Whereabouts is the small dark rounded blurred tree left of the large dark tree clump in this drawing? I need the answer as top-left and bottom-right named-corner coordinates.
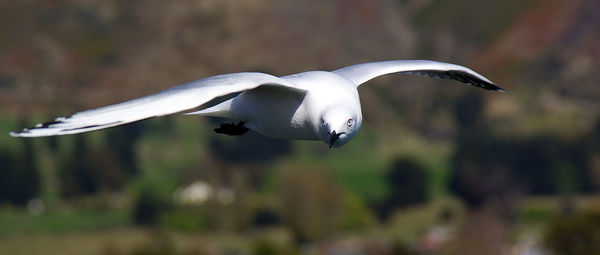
top-left (375, 157), bottom-right (427, 220)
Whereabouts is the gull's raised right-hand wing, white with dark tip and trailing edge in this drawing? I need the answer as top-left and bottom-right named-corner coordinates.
top-left (333, 60), bottom-right (510, 93)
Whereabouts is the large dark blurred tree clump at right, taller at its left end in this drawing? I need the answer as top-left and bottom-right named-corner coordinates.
top-left (450, 93), bottom-right (594, 206)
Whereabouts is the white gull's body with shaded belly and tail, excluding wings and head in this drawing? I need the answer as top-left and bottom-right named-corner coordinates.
top-left (195, 71), bottom-right (362, 140)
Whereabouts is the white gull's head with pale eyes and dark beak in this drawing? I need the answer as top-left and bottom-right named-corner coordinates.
top-left (319, 107), bottom-right (362, 148)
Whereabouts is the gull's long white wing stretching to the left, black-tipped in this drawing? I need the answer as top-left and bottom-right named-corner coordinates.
top-left (10, 73), bottom-right (299, 137)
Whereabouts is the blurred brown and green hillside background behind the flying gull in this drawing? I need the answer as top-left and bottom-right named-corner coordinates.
top-left (0, 0), bottom-right (600, 255)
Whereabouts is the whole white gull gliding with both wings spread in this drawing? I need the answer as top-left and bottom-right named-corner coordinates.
top-left (10, 60), bottom-right (510, 148)
